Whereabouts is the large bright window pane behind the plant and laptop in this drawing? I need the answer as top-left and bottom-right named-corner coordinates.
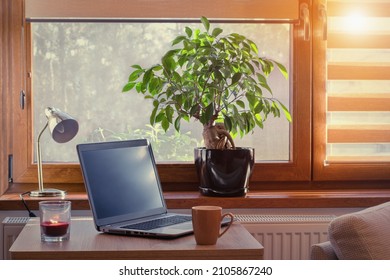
top-left (32, 23), bottom-right (292, 162)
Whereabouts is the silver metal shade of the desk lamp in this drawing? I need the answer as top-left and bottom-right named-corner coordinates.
top-left (45, 107), bottom-right (79, 143)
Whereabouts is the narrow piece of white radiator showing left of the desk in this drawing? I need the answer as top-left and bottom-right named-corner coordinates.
top-left (2, 217), bottom-right (29, 260)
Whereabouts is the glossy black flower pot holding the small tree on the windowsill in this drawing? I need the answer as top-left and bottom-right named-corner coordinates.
top-left (194, 148), bottom-right (255, 197)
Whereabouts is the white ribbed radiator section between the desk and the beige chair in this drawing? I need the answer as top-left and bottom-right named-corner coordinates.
top-left (235, 215), bottom-right (335, 260)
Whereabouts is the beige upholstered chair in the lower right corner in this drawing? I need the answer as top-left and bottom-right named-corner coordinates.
top-left (310, 202), bottom-right (390, 260)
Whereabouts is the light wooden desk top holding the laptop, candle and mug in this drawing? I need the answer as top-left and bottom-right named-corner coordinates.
top-left (10, 217), bottom-right (263, 260)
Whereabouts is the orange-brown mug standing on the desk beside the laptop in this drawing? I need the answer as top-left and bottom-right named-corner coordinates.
top-left (192, 206), bottom-right (234, 245)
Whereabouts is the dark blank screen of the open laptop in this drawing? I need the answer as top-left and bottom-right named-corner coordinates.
top-left (77, 140), bottom-right (165, 226)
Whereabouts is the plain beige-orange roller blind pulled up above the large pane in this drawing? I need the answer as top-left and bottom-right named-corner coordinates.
top-left (25, 0), bottom-right (299, 21)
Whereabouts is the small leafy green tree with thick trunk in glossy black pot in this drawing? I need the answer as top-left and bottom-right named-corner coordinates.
top-left (123, 17), bottom-right (291, 196)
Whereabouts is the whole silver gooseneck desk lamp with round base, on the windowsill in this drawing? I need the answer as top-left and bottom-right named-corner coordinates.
top-left (30, 107), bottom-right (79, 197)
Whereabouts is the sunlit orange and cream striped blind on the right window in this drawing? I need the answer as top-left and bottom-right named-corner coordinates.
top-left (326, 0), bottom-right (390, 164)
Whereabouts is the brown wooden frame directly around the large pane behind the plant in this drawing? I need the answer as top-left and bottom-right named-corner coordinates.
top-left (7, 1), bottom-right (311, 190)
